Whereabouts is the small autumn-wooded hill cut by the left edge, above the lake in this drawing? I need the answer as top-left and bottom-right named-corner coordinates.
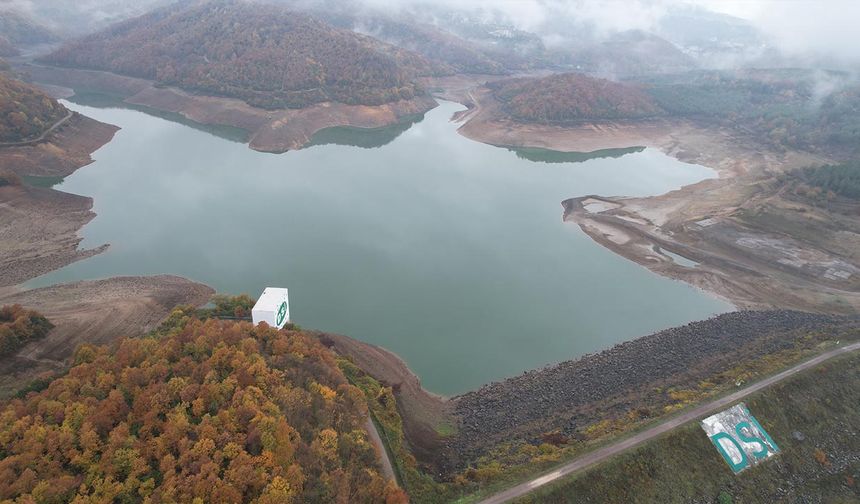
top-left (0, 71), bottom-right (68, 142)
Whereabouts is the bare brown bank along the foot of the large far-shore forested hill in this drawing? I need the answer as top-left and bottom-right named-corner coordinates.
top-left (21, 65), bottom-right (437, 153)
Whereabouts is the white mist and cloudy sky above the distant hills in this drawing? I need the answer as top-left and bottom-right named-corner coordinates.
top-left (0, 0), bottom-right (860, 71)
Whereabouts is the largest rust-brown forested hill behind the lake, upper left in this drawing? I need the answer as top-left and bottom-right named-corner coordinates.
top-left (44, 0), bottom-right (440, 108)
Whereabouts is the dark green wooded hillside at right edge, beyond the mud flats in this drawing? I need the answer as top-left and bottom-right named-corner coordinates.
top-left (639, 69), bottom-right (860, 158)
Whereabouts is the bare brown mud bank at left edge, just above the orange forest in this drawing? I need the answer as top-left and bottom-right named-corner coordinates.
top-left (0, 275), bottom-right (213, 397)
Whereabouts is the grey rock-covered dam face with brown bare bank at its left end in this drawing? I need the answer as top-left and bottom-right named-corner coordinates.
top-left (315, 310), bottom-right (860, 479)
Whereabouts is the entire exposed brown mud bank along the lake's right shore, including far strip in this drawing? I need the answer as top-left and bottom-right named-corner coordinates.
top-left (459, 88), bottom-right (860, 314)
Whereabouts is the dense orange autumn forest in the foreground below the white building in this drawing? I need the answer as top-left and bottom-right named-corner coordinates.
top-left (0, 310), bottom-right (407, 504)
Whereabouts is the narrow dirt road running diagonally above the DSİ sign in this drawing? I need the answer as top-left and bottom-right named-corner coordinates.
top-left (481, 343), bottom-right (860, 504)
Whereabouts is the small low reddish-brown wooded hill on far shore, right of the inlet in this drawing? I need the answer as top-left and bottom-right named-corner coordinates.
top-left (487, 73), bottom-right (663, 122)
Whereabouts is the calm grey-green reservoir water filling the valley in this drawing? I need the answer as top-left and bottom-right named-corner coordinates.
top-left (32, 98), bottom-right (731, 394)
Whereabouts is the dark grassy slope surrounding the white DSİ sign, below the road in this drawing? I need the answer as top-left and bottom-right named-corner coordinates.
top-left (522, 353), bottom-right (860, 503)
